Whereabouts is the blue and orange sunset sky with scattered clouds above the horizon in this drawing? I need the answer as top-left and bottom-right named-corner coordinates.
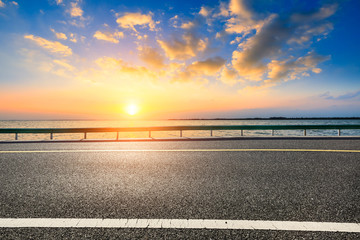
top-left (0, 0), bottom-right (360, 120)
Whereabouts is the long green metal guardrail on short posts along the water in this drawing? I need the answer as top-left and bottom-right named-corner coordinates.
top-left (0, 125), bottom-right (360, 140)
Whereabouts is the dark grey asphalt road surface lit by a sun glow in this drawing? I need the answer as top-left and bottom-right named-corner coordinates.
top-left (0, 139), bottom-right (360, 239)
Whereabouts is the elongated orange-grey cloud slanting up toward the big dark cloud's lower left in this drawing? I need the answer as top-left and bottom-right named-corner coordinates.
top-left (173, 57), bottom-right (226, 82)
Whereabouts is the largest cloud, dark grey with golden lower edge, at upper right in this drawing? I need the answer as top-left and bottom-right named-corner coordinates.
top-left (227, 1), bottom-right (336, 83)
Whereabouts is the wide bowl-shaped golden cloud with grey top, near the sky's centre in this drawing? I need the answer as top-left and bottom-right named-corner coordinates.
top-left (157, 32), bottom-right (208, 60)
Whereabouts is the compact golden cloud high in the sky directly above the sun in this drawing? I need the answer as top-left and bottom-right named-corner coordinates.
top-left (116, 13), bottom-right (155, 32)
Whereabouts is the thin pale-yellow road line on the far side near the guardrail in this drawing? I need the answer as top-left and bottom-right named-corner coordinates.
top-left (0, 148), bottom-right (360, 154)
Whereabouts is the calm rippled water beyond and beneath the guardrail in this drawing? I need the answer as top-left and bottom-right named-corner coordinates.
top-left (0, 119), bottom-right (360, 141)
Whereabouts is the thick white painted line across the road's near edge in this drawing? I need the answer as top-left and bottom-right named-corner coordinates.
top-left (0, 218), bottom-right (360, 232)
